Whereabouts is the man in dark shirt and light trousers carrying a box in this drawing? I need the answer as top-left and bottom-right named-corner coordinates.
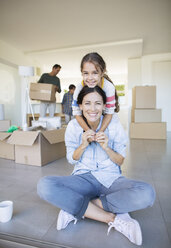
top-left (38, 64), bottom-right (61, 117)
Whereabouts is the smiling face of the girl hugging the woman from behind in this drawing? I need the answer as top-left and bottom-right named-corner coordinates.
top-left (82, 62), bottom-right (103, 88)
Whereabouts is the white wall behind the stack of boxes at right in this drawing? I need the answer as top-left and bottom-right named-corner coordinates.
top-left (128, 53), bottom-right (171, 131)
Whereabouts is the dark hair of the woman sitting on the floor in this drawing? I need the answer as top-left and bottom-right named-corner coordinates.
top-left (77, 85), bottom-right (106, 104)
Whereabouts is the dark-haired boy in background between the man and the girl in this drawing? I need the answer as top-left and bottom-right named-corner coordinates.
top-left (62, 84), bottom-right (75, 124)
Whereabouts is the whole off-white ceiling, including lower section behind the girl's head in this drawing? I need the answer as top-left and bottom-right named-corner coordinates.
top-left (0, 0), bottom-right (171, 76)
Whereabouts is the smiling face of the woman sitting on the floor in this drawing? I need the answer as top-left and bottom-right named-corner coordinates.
top-left (80, 92), bottom-right (105, 125)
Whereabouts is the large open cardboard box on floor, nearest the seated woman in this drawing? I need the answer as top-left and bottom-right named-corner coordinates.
top-left (9, 128), bottom-right (66, 166)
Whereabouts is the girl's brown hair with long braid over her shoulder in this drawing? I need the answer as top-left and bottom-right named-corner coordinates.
top-left (80, 52), bottom-right (120, 113)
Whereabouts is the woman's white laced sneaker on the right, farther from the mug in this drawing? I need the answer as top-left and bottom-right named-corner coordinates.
top-left (108, 213), bottom-right (142, 245)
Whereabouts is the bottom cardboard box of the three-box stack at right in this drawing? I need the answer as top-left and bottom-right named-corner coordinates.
top-left (130, 122), bottom-right (166, 139)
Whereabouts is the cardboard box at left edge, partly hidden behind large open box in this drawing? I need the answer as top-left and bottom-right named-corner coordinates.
top-left (0, 132), bottom-right (15, 160)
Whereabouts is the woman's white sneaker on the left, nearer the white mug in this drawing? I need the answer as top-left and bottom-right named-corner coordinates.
top-left (56, 209), bottom-right (77, 231)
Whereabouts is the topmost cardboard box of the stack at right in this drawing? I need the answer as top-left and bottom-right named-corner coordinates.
top-left (132, 86), bottom-right (156, 109)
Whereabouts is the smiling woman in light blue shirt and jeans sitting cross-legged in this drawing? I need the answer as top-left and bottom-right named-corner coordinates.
top-left (38, 86), bottom-right (155, 245)
